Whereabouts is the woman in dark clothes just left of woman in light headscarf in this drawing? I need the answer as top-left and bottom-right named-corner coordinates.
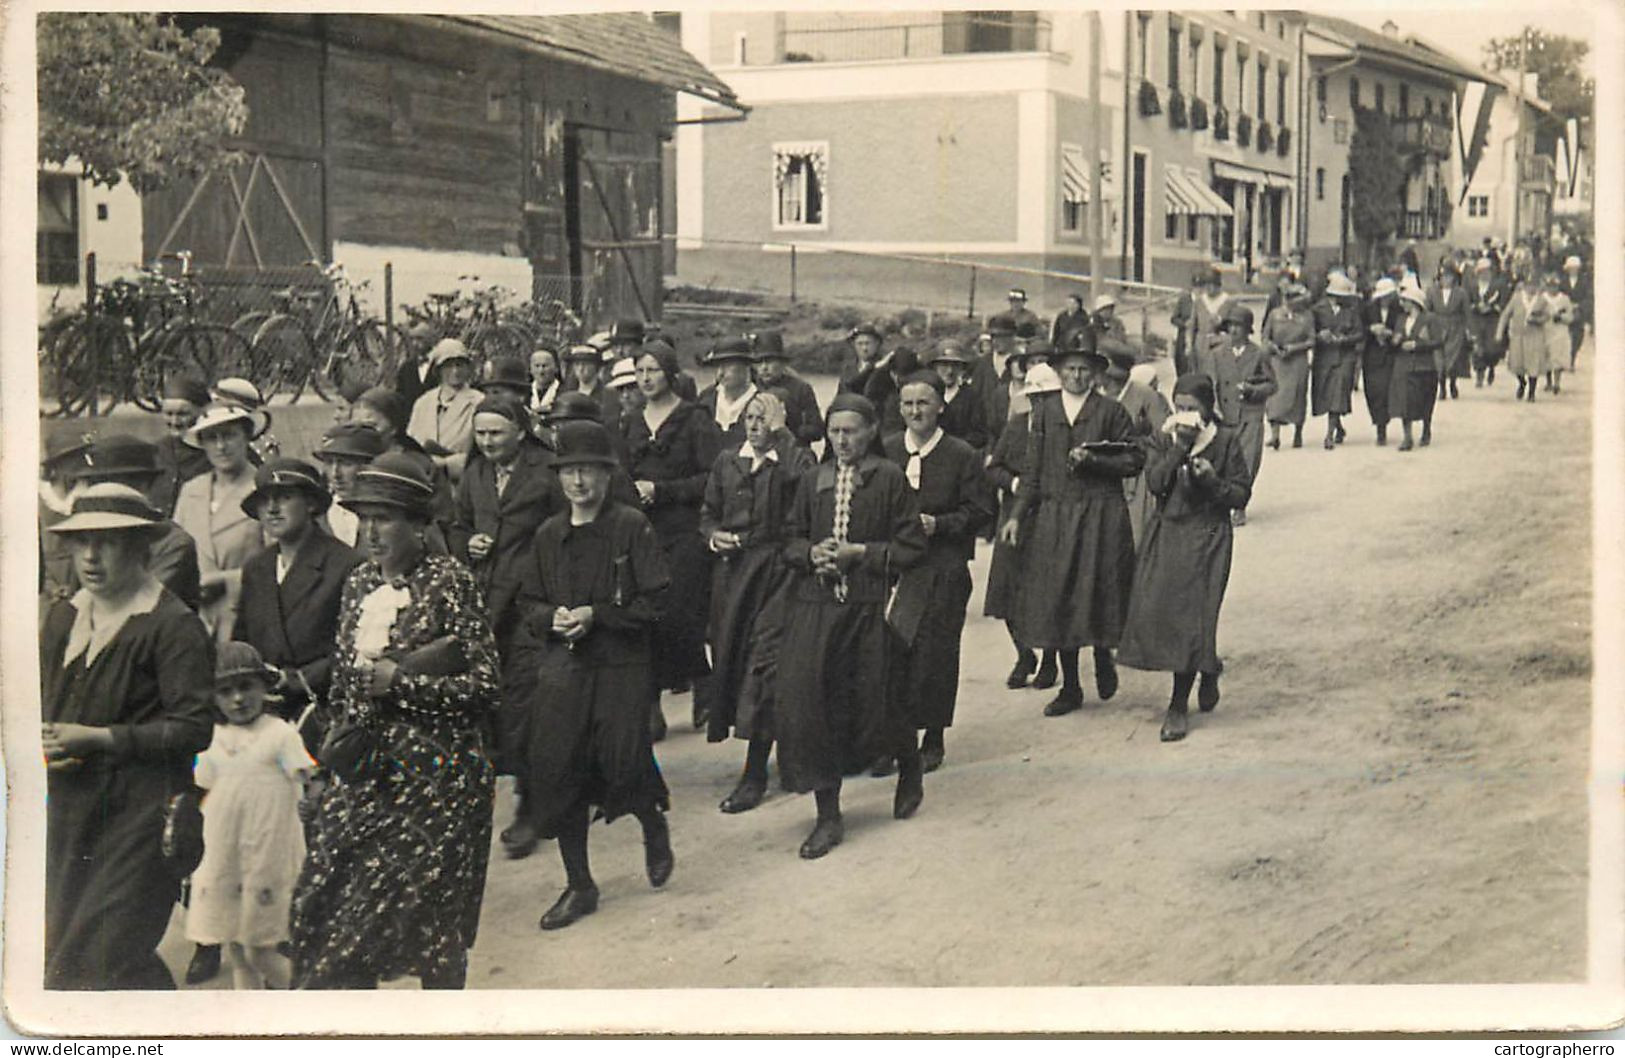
top-left (621, 343), bottom-right (722, 728)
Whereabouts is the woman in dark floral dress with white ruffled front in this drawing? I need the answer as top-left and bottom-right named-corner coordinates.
top-left (293, 453), bottom-right (497, 988)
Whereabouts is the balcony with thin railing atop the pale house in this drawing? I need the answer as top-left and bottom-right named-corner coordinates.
top-left (777, 11), bottom-right (1050, 62)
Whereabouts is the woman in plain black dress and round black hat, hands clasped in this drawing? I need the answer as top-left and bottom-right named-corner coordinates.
top-left (522, 421), bottom-right (676, 930)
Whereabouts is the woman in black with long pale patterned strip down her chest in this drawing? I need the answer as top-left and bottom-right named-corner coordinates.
top-left (774, 393), bottom-right (926, 860)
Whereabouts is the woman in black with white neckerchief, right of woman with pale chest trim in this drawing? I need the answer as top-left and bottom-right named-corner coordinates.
top-left (886, 372), bottom-right (993, 772)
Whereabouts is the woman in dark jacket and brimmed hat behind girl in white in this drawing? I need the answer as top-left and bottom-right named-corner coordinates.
top-left (231, 458), bottom-right (361, 752)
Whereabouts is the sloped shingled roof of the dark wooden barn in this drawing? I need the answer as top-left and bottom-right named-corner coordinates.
top-left (434, 11), bottom-right (746, 111)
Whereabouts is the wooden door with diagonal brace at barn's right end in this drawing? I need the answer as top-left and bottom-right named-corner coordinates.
top-left (566, 128), bottom-right (661, 327)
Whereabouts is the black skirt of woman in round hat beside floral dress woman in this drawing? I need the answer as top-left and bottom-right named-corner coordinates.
top-left (525, 640), bottom-right (671, 837)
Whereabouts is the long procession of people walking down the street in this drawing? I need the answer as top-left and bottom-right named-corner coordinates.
top-left (41, 240), bottom-right (1589, 988)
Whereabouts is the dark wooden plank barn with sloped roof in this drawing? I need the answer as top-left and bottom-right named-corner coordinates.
top-left (141, 13), bottom-right (743, 323)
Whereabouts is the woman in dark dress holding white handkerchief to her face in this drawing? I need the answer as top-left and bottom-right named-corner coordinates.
top-left (1118, 374), bottom-right (1251, 743)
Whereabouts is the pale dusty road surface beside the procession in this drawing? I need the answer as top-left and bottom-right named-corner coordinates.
top-left (143, 349), bottom-right (1591, 988)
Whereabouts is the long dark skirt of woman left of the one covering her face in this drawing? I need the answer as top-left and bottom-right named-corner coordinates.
top-left (1014, 494), bottom-right (1131, 650)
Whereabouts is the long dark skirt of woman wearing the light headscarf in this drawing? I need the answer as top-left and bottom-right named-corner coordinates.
top-left (705, 546), bottom-right (790, 743)
